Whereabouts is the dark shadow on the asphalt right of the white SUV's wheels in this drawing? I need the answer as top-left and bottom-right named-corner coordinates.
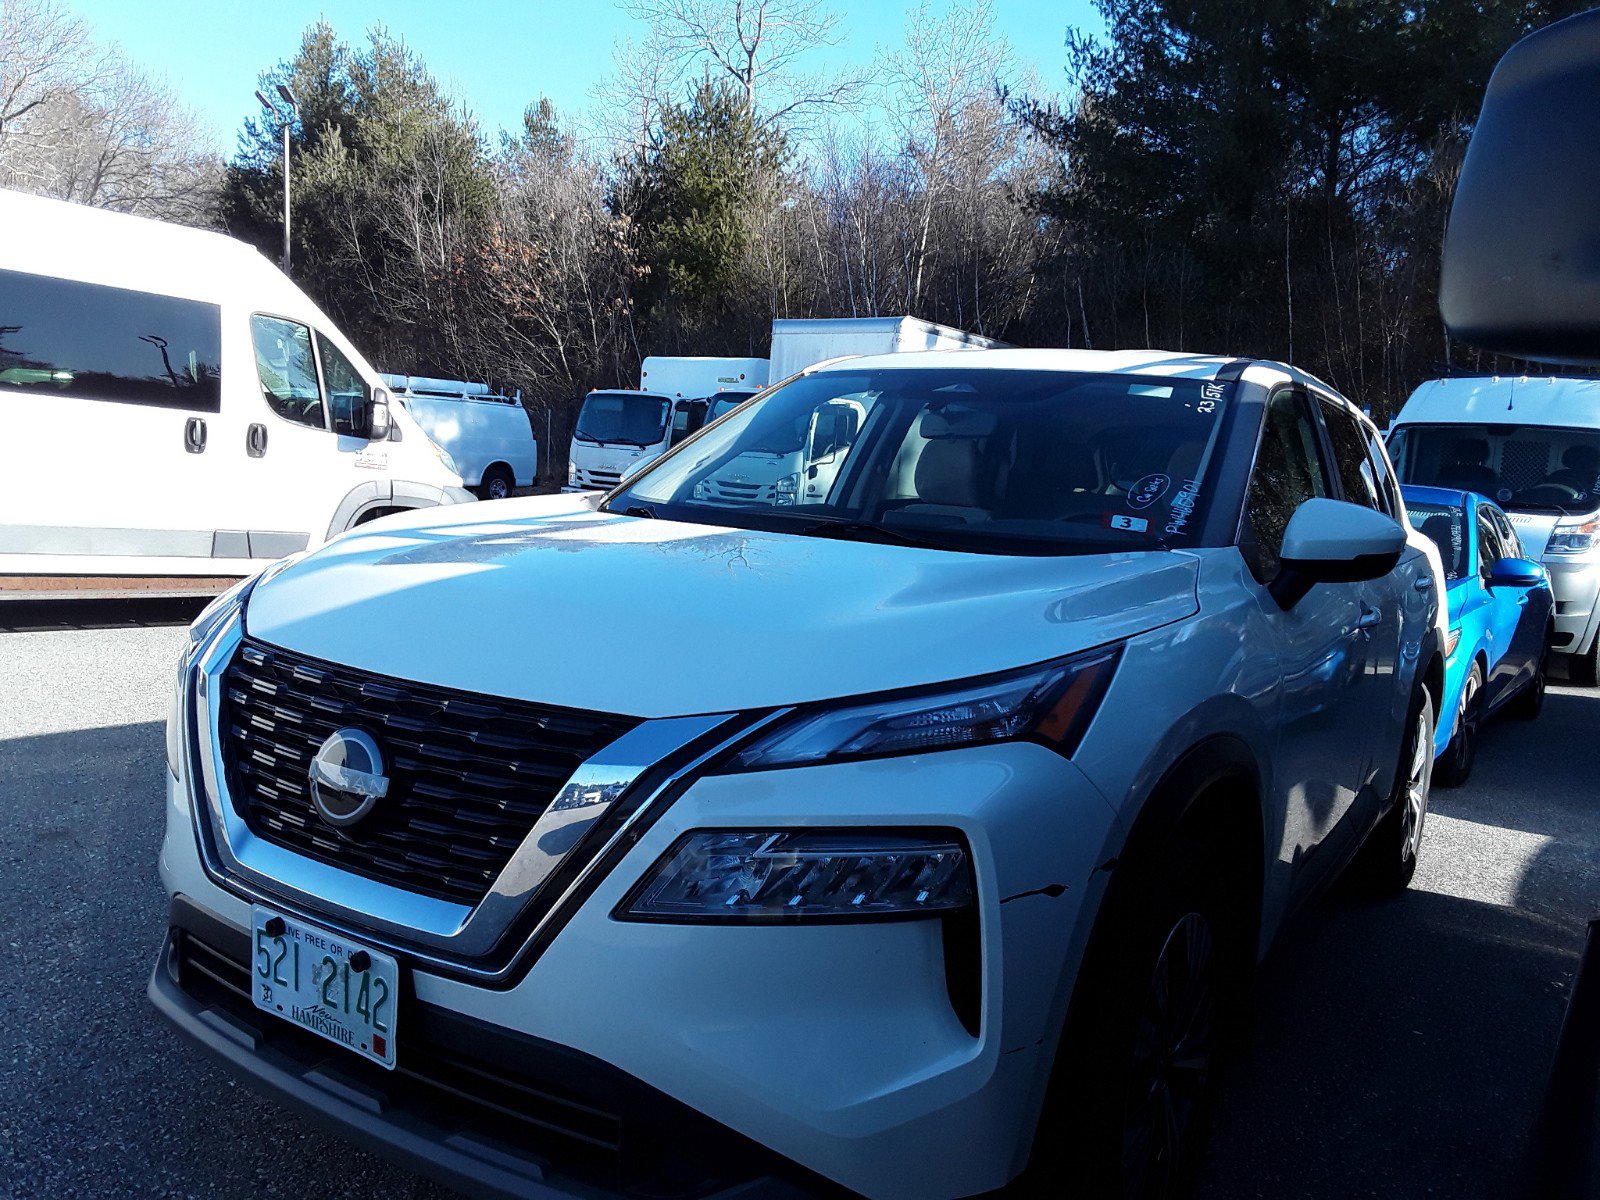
top-left (1197, 891), bottom-right (1582, 1200)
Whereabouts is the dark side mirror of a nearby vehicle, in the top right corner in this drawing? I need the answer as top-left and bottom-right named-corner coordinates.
top-left (1438, 10), bottom-right (1600, 363)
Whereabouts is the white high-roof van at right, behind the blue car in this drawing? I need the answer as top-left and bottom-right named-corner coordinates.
top-left (1389, 376), bottom-right (1600, 685)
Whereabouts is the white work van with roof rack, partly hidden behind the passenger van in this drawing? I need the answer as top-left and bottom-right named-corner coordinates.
top-left (382, 373), bottom-right (539, 499)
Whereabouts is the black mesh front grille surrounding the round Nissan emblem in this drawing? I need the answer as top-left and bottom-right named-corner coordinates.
top-left (219, 640), bottom-right (638, 906)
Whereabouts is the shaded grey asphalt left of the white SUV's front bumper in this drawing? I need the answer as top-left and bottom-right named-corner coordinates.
top-left (0, 722), bottom-right (450, 1200)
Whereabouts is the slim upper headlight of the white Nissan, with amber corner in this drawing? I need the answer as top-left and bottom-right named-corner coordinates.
top-left (725, 645), bottom-right (1122, 771)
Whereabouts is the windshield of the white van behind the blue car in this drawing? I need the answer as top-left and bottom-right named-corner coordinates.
top-left (1389, 424), bottom-right (1600, 512)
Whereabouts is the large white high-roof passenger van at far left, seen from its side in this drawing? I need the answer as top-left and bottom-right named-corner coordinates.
top-left (0, 190), bottom-right (472, 598)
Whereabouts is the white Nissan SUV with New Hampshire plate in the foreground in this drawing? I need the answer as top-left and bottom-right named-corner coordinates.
top-left (150, 350), bottom-right (1443, 1200)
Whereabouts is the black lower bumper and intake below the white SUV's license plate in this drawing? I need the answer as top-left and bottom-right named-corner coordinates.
top-left (149, 896), bottom-right (840, 1200)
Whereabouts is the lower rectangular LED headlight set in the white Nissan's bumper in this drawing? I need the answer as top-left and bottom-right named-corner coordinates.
top-left (616, 829), bottom-right (974, 922)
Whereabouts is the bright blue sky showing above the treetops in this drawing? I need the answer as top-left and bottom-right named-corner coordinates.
top-left (67, 0), bottom-right (1099, 154)
